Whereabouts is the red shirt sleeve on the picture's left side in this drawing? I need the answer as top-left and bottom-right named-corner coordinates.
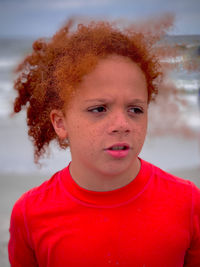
top-left (8, 196), bottom-right (38, 267)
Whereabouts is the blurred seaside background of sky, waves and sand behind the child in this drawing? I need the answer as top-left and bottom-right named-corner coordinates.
top-left (0, 0), bottom-right (200, 267)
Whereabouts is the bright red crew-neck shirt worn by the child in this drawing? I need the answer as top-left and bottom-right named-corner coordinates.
top-left (9, 160), bottom-right (200, 267)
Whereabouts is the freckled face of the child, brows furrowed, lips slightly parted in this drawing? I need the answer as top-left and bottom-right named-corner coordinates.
top-left (52, 56), bottom-right (148, 182)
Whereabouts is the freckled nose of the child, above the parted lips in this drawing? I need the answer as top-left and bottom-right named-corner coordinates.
top-left (108, 112), bottom-right (131, 135)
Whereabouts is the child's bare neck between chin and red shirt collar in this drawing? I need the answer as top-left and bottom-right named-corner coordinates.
top-left (69, 158), bottom-right (141, 192)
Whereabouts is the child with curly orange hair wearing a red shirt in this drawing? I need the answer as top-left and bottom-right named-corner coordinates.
top-left (9, 18), bottom-right (200, 267)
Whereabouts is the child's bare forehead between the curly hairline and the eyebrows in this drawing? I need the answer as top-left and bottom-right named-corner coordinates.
top-left (65, 56), bottom-right (148, 106)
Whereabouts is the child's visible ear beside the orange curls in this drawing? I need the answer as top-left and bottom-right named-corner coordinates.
top-left (50, 109), bottom-right (67, 140)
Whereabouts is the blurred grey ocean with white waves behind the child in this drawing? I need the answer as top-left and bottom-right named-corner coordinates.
top-left (0, 36), bottom-right (200, 173)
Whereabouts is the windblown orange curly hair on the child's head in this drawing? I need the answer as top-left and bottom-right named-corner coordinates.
top-left (14, 17), bottom-right (165, 162)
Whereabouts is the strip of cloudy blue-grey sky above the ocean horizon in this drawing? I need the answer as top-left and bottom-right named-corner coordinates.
top-left (0, 0), bottom-right (200, 38)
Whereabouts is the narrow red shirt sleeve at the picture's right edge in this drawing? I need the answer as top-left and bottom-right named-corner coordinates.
top-left (184, 185), bottom-right (200, 267)
